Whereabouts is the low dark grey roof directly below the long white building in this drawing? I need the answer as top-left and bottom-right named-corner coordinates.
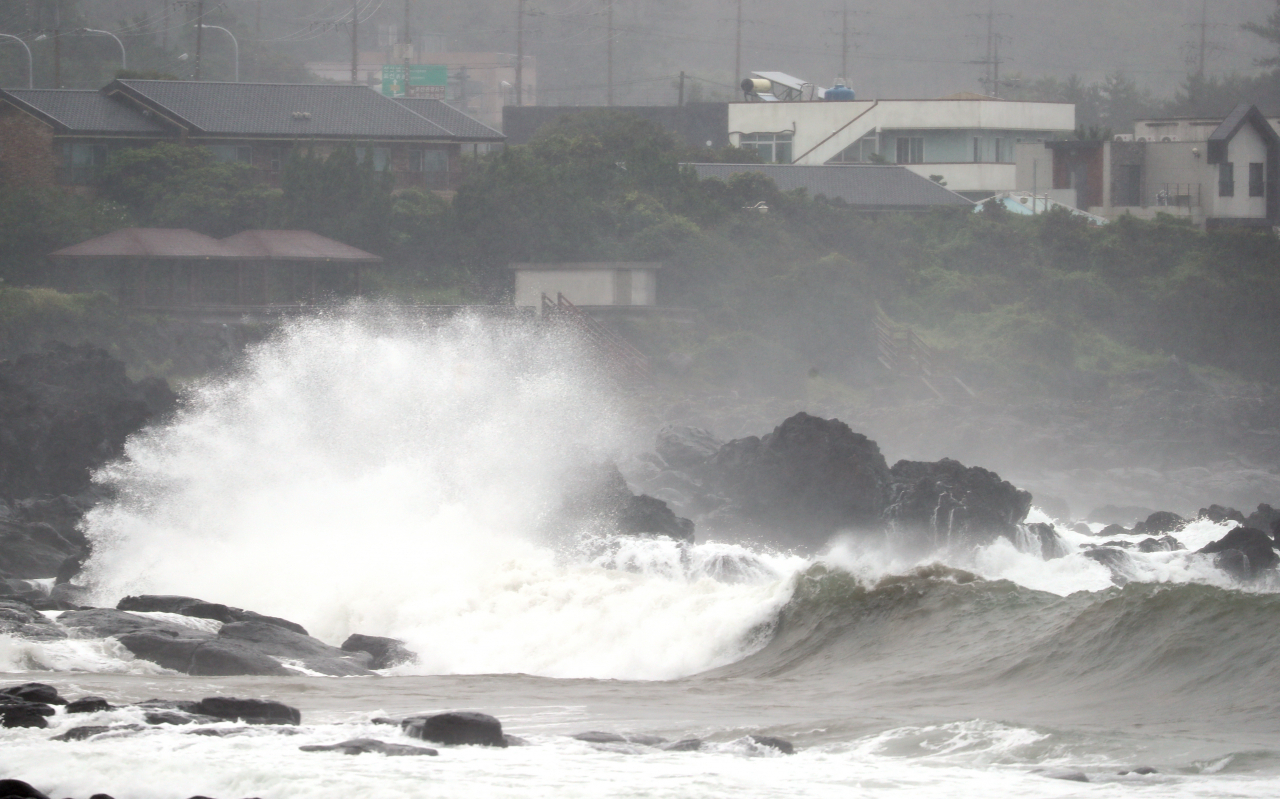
top-left (690, 164), bottom-right (973, 209)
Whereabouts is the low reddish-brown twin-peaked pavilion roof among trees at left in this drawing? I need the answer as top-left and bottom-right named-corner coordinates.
top-left (49, 228), bottom-right (383, 264)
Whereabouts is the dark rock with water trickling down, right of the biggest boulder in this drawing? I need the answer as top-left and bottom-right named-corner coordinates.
top-left (884, 458), bottom-right (1032, 545)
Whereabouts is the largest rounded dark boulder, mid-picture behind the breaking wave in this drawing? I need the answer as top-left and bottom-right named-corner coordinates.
top-left (703, 414), bottom-right (890, 547)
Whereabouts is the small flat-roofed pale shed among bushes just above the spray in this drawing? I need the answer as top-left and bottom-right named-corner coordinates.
top-left (511, 261), bottom-right (662, 309)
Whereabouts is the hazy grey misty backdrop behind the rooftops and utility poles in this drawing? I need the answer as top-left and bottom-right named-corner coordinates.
top-left (10, 0), bottom-right (1276, 105)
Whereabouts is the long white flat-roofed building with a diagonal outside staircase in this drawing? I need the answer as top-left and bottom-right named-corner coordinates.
top-left (728, 93), bottom-right (1075, 198)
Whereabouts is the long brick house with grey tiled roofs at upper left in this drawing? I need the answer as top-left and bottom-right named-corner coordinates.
top-left (0, 79), bottom-right (503, 191)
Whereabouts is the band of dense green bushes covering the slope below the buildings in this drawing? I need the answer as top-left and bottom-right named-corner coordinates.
top-left (0, 113), bottom-right (1280, 394)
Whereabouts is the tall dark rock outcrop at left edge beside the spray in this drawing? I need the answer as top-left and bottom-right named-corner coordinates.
top-left (0, 343), bottom-right (177, 499)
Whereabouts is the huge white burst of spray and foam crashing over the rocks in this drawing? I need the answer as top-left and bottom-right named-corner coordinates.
top-left (86, 311), bottom-right (792, 679)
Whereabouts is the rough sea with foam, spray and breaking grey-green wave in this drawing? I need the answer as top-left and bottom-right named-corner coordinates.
top-left (0, 309), bottom-right (1280, 799)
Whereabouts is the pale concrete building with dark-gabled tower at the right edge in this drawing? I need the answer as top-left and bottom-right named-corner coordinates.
top-left (1018, 105), bottom-right (1280, 227)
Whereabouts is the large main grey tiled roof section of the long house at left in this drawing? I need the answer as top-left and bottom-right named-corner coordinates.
top-left (102, 79), bottom-right (454, 140)
